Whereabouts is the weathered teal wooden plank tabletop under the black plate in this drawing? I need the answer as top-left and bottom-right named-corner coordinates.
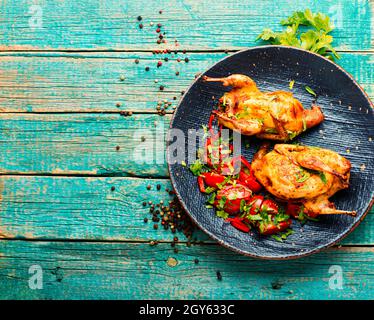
top-left (0, 0), bottom-right (374, 299)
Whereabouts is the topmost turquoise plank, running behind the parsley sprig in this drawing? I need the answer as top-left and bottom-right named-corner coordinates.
top-left (0, 0), bottom-right (372, 50)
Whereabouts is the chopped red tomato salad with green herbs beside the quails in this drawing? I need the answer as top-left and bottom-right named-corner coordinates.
top-left (186, 115), bottom-right (314, 241)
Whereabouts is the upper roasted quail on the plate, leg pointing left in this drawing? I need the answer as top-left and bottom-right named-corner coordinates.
top-left (203, 74), bottom-right (324, 141)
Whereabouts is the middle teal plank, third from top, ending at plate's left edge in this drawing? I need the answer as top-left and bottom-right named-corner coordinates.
top-left (0, 113), bottom-right (170, 177)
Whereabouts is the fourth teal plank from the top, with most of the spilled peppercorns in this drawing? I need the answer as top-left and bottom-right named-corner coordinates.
top-left (0, 176), bottom-right (374, 245)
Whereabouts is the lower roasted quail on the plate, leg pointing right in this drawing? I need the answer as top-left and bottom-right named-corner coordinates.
top-left (252, 144), bottom-right (356, 215)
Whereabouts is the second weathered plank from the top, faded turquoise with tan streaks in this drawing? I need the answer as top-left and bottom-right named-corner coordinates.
top-left (0, 53), bottom-right (374, 112)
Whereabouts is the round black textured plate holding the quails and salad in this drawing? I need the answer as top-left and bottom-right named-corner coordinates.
top-left (168, 46), bottom-right (374, 259)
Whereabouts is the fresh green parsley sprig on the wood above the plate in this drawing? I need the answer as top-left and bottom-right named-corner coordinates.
top-left (256, 9), bottom-right (340, 60)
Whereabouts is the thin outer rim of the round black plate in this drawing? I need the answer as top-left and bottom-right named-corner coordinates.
top-left (166, 45), bottom-right (374, 261)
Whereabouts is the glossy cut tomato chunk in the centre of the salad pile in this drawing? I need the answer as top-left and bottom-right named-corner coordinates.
top-left (214, 183), bottom-right (252, 214)
